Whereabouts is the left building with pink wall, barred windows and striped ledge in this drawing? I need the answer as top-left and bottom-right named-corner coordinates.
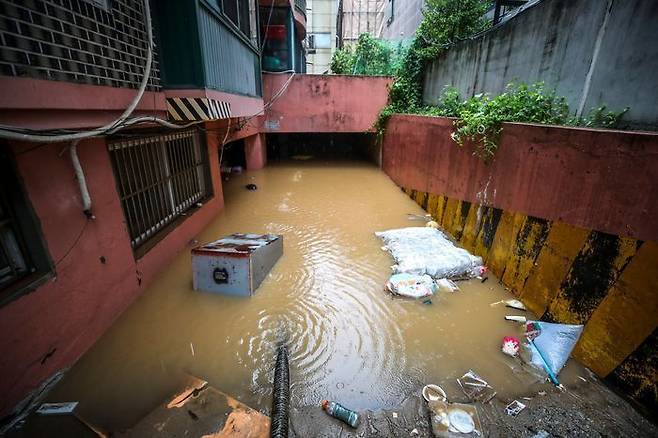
top-left (0, 0), bottom-right (306, 416)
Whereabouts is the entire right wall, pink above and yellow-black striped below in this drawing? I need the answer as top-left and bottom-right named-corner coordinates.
top-left (382, 115), bottom-right (658, 408)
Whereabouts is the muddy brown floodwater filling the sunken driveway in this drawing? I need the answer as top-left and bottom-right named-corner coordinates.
top-left (49, 161), bottom-right (581, 430)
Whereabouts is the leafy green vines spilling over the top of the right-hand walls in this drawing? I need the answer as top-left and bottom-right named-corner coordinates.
top-left (332, 0), bottom-right (628, 160)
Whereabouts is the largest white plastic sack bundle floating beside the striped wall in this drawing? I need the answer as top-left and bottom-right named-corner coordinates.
top-left (375, 227), bottom-right (482, 278)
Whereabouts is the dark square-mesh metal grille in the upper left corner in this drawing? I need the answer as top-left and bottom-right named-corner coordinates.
top-left (0, 0), bottom-right (160, 90)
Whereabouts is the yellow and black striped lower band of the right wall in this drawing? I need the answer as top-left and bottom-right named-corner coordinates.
top-left (402, 188), bottom-right (658, 412)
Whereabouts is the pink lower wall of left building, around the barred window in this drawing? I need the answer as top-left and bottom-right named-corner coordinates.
top-left (0, 134), bottom-right (223, 415)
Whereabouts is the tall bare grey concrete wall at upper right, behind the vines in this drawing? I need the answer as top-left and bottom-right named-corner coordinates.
top-left (424, 0), bottom-right (658, 128)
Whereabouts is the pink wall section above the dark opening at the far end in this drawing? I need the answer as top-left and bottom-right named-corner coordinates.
top-left (263, 74), bottom-right (392, 133)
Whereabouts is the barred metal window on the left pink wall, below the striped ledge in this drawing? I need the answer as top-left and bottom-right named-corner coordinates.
top-left (109, 130), bottom-right (210, 248)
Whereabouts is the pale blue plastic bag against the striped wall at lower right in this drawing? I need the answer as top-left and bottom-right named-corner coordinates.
top-left (525, 321), bottom-right (583, 376)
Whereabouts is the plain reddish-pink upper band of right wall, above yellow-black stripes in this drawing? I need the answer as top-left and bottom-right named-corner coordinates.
top-left (383, 115), bottom-right (658, 241)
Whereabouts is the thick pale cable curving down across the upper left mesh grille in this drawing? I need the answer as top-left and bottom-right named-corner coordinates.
top-left (0, 0), bottom-right (153, 143)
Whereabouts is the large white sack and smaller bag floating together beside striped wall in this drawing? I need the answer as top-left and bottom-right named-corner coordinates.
top-left (375, 226), bottom-right (486, 298)
